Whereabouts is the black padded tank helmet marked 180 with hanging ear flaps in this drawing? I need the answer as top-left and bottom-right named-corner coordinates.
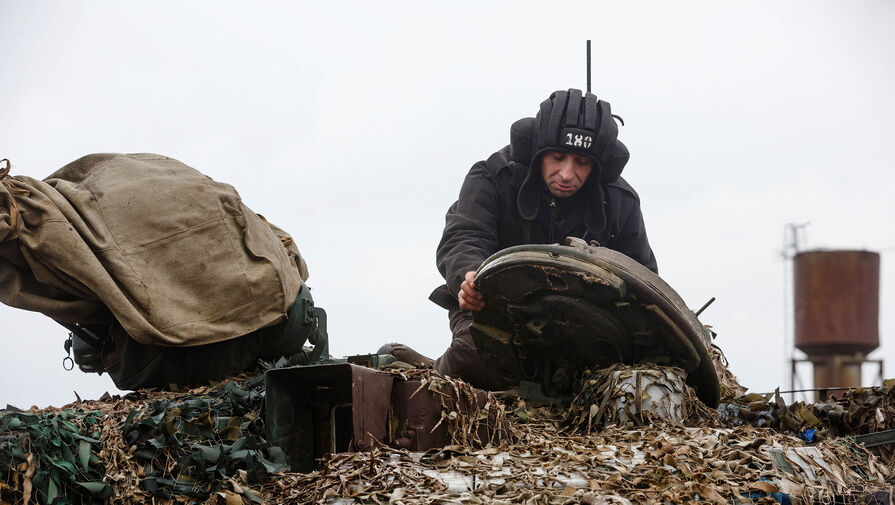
top-left (510, 89), bottom-right (630, 233)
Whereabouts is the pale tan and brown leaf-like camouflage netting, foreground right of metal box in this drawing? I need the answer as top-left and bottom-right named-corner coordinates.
top-left (265, 423), bottom-right (892, 504)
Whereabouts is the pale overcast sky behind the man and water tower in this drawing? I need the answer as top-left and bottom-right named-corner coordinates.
top-left (0, 0), bottom-right (895, 408)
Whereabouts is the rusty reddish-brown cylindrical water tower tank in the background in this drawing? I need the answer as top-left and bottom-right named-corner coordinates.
top-left (793, 250), bottom-right (879, 356)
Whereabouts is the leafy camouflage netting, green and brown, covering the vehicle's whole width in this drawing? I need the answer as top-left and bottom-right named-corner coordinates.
top-left (0, 367), bottom-right (895, 505)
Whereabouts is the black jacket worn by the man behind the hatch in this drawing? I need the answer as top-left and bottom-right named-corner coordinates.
top-left (429, 146), bottom-right (658, 309)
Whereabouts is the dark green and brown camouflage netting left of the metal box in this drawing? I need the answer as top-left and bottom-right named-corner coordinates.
top-left (0, 381), bottom-right (286, 504)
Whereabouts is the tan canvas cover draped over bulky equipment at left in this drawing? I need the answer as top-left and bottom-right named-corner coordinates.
top-left (0, 154), bottom-right (308, 346)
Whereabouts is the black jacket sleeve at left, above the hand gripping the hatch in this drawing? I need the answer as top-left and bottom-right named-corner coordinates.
top-left (435, 161), bottom-right (500, 298)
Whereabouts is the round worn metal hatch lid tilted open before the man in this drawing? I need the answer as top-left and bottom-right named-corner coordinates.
top-left (471, 239), bottom-right (720, 407)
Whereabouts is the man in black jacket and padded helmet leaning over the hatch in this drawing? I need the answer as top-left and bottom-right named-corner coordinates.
top-left (380, 89), bottom-right (658, 389)
